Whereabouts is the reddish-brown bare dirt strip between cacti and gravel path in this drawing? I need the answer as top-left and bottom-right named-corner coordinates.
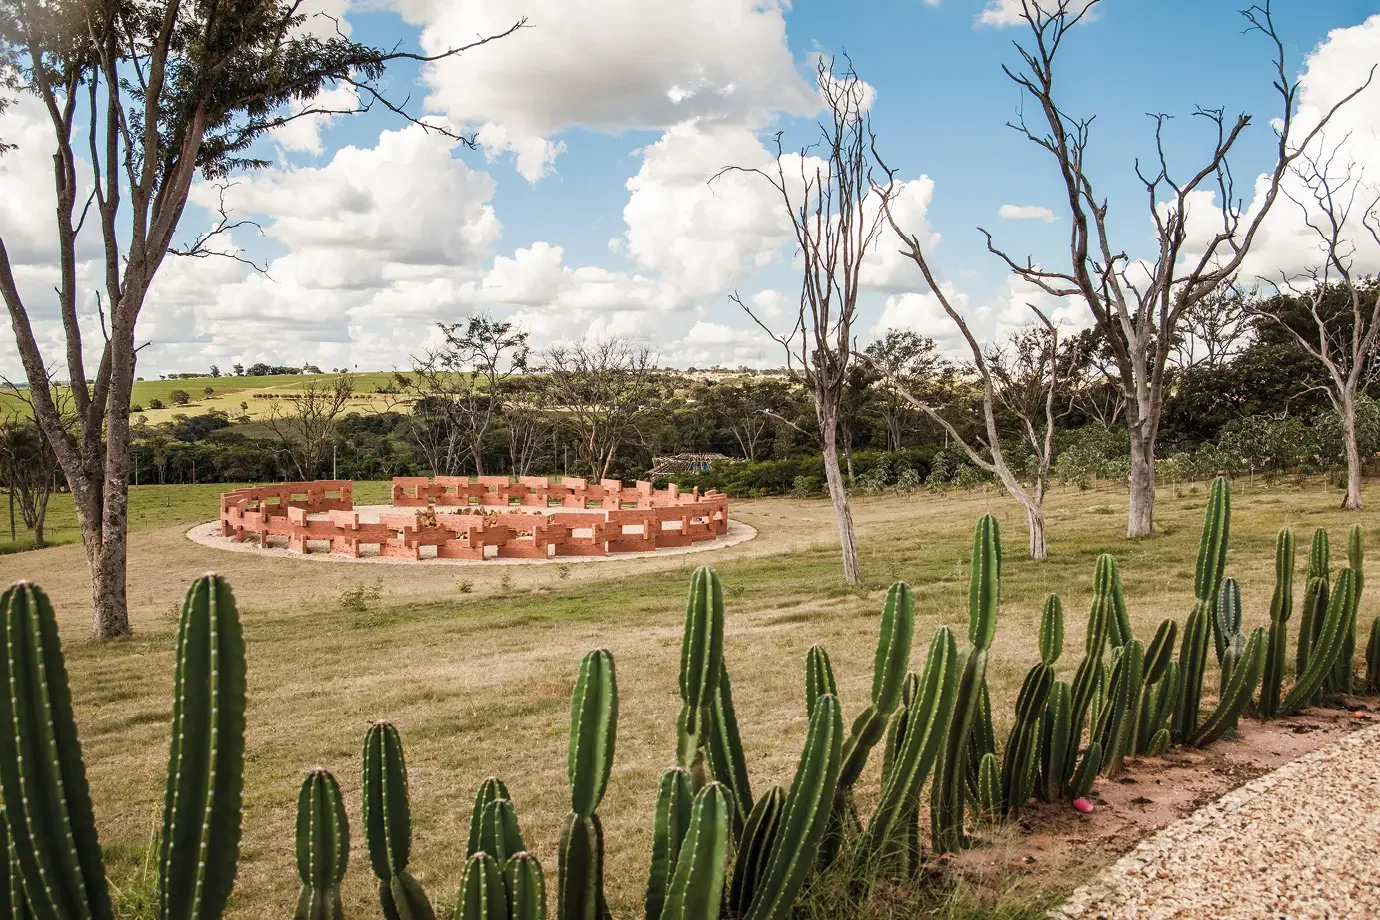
top-left (941, 697), bottom-right (1380, 891)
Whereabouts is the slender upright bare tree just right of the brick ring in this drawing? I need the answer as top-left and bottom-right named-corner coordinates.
top-left (719, 58), bottom-right (894, 585)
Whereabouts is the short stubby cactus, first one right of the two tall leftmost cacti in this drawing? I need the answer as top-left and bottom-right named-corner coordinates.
top-left (293, 768), bottom-right (349, 920)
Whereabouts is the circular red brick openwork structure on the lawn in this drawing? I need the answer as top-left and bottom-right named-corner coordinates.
top-left (221, 476), bottom-right (729, 560)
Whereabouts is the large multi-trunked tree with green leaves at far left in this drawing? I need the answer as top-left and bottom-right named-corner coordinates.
top-left (0, 0), bottom-right (524, 637)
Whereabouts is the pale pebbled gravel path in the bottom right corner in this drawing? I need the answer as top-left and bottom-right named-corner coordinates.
top-left (1049, 726), bottom-right (1380, 920)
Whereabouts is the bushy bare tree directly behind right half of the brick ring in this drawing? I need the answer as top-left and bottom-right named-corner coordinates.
top-left (544, 338), bottom-right (657, 481)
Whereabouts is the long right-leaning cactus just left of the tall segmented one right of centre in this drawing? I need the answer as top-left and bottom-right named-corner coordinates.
top-left (863, 626), bottom-right (959, 868)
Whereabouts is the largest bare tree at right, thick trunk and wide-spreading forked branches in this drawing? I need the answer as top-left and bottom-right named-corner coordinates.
top-left (983, 0), bottom-right (1374, 537)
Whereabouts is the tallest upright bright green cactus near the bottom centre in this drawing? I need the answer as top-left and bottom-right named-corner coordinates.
top-left (676, 566), bottom-right (723, 785)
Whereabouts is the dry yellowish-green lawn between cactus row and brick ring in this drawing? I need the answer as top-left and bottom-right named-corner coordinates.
top-left (0, 484), bottom-right (1363, 917)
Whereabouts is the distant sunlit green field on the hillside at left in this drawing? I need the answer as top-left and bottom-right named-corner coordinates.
top-left (0, 371), bottom-right (393, 423)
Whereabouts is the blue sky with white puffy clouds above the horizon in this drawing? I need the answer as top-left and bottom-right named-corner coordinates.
top-left (0, 0), bottom-right (1380, 379)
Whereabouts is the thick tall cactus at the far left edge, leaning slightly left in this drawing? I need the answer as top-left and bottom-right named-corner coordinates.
top-left (0, 582), bottom-right (114, 920)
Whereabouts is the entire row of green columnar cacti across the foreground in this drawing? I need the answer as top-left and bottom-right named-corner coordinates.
top-left (0, 480), bottom-right (1380, 920)
